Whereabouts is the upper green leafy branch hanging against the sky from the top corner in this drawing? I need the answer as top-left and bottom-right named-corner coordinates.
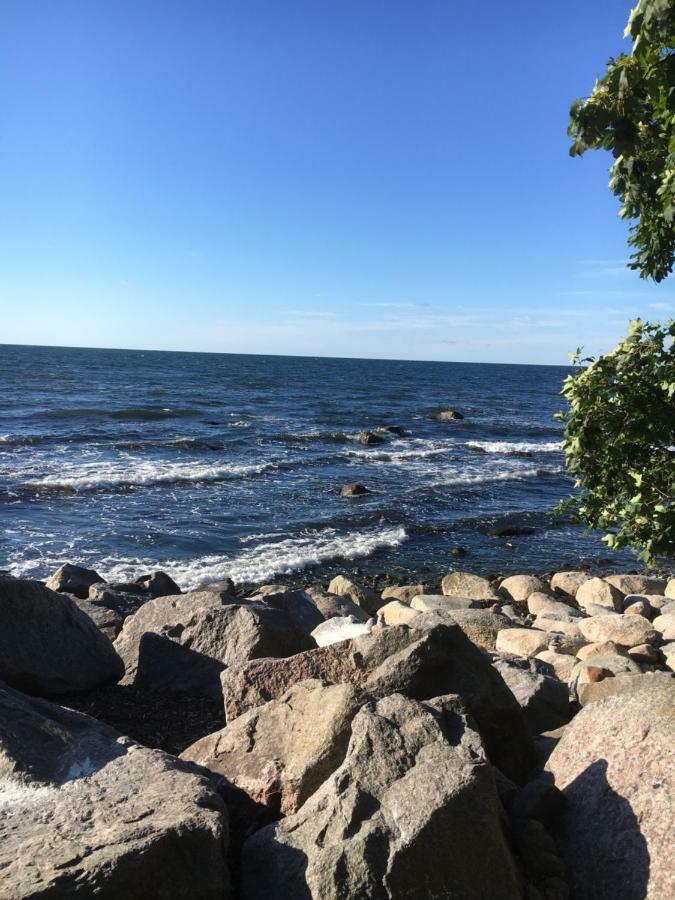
top-left (568, 0), bottom-right (675, 281)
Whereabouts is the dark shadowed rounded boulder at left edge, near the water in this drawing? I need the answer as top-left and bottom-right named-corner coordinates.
top-left (0, 577), bottom-right (124, 697)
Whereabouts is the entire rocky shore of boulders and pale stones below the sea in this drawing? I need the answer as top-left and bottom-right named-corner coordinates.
top-left (0, 565), bottom-right (675, 900)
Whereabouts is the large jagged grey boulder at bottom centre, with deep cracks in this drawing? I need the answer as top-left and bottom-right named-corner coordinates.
top-left (242, 695), bottom-right (523, 900)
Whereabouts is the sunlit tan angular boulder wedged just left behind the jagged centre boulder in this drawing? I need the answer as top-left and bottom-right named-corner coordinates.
top-left (181, 680), bottom-right (367, 821)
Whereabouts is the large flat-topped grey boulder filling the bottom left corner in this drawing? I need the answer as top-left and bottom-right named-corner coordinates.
top-left (0, 688), bottom-right (228, 900)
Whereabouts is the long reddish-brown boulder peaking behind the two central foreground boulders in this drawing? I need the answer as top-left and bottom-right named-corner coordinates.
top-left (221, 613), bottom-right (535, 781)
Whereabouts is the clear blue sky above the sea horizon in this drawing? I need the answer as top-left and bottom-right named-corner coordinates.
top-left (0, 0), bottom-right (675, 363)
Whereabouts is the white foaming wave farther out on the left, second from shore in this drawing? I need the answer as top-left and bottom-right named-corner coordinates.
top-left (24, 459), bottom-right (276, 491)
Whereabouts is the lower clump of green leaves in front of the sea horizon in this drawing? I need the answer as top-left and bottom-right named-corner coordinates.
top-left (559, 319), bottom-right (675, 563)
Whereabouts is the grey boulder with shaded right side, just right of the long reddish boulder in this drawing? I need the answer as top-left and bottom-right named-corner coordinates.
top-left (492, 656), bottom-right (572, 734)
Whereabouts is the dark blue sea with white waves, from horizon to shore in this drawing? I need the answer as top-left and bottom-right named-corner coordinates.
top-left (0, 346), bottom-right (627, 587)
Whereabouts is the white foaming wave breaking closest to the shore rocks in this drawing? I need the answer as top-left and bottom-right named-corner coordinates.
top-left (76, 526), bottom-right (408, 590)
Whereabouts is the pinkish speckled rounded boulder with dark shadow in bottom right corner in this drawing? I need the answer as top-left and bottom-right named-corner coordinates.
top-left (546, 679), bottom-right (675, 900)
